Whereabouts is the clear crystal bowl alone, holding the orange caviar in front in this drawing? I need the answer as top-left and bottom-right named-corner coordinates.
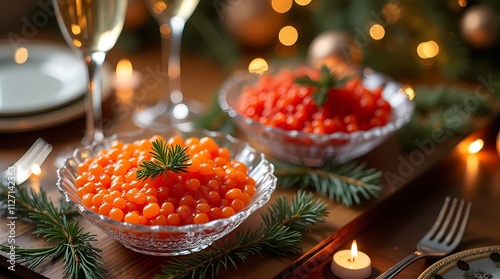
top-left (57, 130), bottom-right (276, 256)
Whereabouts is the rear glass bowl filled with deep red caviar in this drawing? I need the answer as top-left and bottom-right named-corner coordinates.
top-left (218, 61), bottom-right (414, 167)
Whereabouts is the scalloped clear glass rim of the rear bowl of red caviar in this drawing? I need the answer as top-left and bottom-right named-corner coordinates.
top-left (218, 64), bottom-right (415, 165)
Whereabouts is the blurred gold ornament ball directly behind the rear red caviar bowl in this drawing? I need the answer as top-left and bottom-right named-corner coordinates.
top-left (307, 31), bottom-right (363, 69)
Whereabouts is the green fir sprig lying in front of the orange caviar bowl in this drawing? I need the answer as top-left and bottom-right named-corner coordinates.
top-left (155, 191), bottom-right (328, 279)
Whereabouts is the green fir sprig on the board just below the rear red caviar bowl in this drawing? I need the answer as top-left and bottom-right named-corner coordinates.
top-left (274, 158), bottom-right (382, 207)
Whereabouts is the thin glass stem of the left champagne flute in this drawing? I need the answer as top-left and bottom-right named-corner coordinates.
top-left (84, 52), bottom-right (106, 143)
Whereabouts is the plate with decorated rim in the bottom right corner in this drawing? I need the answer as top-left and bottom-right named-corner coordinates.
top-left (418, 246), bottom-right (500, 279)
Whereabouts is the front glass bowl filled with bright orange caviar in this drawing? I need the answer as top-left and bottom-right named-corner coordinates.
top-left (57, 129), bottom-right (276, 256)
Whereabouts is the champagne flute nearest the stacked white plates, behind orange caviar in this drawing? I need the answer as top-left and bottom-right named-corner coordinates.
top-left (52, 0), bottom-right (128, 144)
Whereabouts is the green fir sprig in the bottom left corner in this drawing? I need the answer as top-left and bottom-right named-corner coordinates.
top-left (0, 185), bottom-right (105, 278)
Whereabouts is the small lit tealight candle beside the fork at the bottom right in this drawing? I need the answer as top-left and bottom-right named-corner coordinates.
top-left (330, 240), bottom-right (372, 279)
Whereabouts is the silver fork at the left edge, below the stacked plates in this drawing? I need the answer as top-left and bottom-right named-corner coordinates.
top-left (0, 138), bottom-right (52, 185)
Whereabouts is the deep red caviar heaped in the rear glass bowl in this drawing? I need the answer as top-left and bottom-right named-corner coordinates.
top-left (236, 67), bottom-right (392, 134)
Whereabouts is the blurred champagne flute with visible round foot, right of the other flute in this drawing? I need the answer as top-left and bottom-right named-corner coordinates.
top-left (132, 0), bottom-right (203, 128)
